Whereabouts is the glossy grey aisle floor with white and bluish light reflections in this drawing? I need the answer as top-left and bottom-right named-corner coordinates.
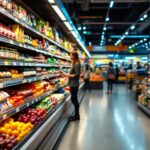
top-left (58, 85), bottom-right (150, 150)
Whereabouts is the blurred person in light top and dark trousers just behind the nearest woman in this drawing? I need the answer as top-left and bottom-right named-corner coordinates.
top-left (81, 64), bottom-right (91, 91)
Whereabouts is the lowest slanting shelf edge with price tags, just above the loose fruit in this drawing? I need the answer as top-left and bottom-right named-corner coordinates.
top-left (0, 85), bottom-right (66, 122)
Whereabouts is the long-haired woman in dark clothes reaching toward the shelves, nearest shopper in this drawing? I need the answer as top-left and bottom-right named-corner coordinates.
top-left (63, 52), bottom-right (81, 121)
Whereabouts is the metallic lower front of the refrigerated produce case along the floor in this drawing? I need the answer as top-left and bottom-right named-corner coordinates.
top-left (15, 83), bottom-right (85, 150)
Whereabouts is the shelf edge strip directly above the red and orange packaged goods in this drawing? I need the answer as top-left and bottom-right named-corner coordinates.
top-left (0, 74), bottom-right (60, 89)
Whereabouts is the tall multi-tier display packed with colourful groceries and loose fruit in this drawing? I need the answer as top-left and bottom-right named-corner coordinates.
top-left (0, 0), bottom-right (86, 150)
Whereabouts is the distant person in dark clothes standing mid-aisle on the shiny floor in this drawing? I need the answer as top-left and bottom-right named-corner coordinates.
top-left (107, 62), bottom-right (115, 94)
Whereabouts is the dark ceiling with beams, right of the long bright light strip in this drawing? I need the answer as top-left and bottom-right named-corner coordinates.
top-left (62, 0), bottom-right (150, 45)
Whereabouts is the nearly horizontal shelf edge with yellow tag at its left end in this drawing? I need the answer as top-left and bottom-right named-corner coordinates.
top-left (0, 60), bottom-right (70, 68)
